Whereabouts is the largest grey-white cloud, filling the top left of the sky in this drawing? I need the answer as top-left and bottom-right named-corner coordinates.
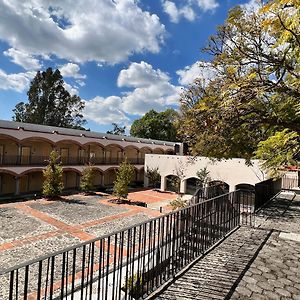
top-left (0, 0), bottom-right (165, 64)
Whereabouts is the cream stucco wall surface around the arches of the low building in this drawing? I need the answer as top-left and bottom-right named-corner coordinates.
top-left (145, 154), bottom-right (267, 192)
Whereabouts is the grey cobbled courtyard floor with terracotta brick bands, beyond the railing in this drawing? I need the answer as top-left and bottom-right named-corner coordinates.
top-left (0, 190), bottom-right (176, 272)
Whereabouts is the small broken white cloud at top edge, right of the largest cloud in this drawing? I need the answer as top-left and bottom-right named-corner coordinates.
top-left (162, 0), bottom-right (219, 23)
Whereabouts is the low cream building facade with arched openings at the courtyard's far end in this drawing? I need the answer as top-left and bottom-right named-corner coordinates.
top-left (145, 154), bottom-right (268, 194)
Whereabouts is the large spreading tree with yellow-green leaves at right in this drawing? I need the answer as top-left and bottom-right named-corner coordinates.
top-left (179, 0), bottom-right (300, 176)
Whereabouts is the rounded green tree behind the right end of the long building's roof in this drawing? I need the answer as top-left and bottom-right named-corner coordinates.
top-left (130, 109), bottom-right (178, 142)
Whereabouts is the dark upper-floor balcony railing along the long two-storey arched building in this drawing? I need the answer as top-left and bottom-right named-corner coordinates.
top-left (0, 155), bottom-right (145, 166)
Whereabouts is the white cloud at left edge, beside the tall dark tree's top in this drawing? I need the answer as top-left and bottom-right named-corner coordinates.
top-left (0, 69), bottom-right (36, 93)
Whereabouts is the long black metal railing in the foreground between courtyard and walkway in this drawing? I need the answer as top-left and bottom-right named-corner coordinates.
top-left (0, 191), bottom-right (252, 300)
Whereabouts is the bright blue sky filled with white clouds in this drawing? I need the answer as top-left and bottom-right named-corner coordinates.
top-left (0, 0), bottom-right (255, 132)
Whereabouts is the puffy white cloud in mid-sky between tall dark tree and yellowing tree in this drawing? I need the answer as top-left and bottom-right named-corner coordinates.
top-left (85, 61), bottom-right (181, 124)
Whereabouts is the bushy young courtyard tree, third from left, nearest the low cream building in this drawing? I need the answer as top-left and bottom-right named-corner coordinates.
top-left (113, 160), bottom-right (134, 199)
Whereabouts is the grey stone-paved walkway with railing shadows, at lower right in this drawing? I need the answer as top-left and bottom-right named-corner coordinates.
top-left (151, 193), bottom-right (300, 300)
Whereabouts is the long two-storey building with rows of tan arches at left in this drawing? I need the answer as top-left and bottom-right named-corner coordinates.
top-left (0, 120), bottom-right (175, 197)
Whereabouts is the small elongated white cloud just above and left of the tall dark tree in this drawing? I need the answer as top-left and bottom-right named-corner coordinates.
top-left (3, 48), bottom-right (41, 70)
